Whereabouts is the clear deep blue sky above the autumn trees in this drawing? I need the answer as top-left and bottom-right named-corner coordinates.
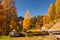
top-left (16, 0), bottom-right (56, 17)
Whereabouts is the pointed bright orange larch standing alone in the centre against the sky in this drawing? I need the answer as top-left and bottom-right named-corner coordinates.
top-left (23, 10), bottom-right (30, 31)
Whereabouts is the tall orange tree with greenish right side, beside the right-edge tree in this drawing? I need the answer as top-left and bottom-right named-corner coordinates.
top-left (48, 4), bottom-right (56, 21)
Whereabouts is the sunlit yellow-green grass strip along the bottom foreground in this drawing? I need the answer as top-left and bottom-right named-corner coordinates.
top-left (0, 35), bottom-right (56, 40)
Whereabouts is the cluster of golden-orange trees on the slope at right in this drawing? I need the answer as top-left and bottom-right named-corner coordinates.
top-left (43, 0), bottom-right (60, 26)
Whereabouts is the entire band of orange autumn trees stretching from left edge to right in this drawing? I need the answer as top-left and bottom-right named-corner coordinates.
top-left (0, 0), bottom-right (60, 35)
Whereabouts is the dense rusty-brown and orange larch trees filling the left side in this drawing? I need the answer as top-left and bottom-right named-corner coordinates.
top-left (0, 0), bottom-right (18, 35)
